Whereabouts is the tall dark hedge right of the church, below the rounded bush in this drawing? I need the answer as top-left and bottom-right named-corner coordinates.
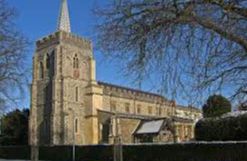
top-left (195, 114), bottom-right (247, 141)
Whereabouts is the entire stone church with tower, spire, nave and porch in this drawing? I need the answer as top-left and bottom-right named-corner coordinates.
top-left (29, 0), bottom-right (202, 145)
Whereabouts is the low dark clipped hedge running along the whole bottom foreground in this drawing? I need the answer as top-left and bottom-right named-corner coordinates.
top-left (0, 142), bottom-right (247, 161)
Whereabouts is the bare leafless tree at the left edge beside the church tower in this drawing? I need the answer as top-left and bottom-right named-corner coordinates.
top-left (0, 0), bottom-right (28, 110)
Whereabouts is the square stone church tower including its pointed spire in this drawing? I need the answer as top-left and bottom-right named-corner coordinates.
top-left (30, 0), bottom-right (97, 145)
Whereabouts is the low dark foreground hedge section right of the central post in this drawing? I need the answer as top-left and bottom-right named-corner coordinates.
top-left (124, 143), bottom-right (247, 161)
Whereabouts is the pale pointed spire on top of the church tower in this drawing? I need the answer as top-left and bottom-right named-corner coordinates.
top-left (57, 0), bottom-right (71, 32)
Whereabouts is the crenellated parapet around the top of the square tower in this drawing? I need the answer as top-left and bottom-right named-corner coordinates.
top-left (36, 31), bottom-right (93, 51)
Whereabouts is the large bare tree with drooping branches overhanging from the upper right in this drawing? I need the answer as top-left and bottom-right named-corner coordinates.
top-left (96, 0), bottom-right (247, 103)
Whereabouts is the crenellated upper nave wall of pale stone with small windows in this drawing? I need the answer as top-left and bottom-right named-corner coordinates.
top-left (99, 83), bottom-right (175, 117)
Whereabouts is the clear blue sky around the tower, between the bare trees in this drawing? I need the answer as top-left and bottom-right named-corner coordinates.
top-left (7, 0), bottom-right (155, 108)
